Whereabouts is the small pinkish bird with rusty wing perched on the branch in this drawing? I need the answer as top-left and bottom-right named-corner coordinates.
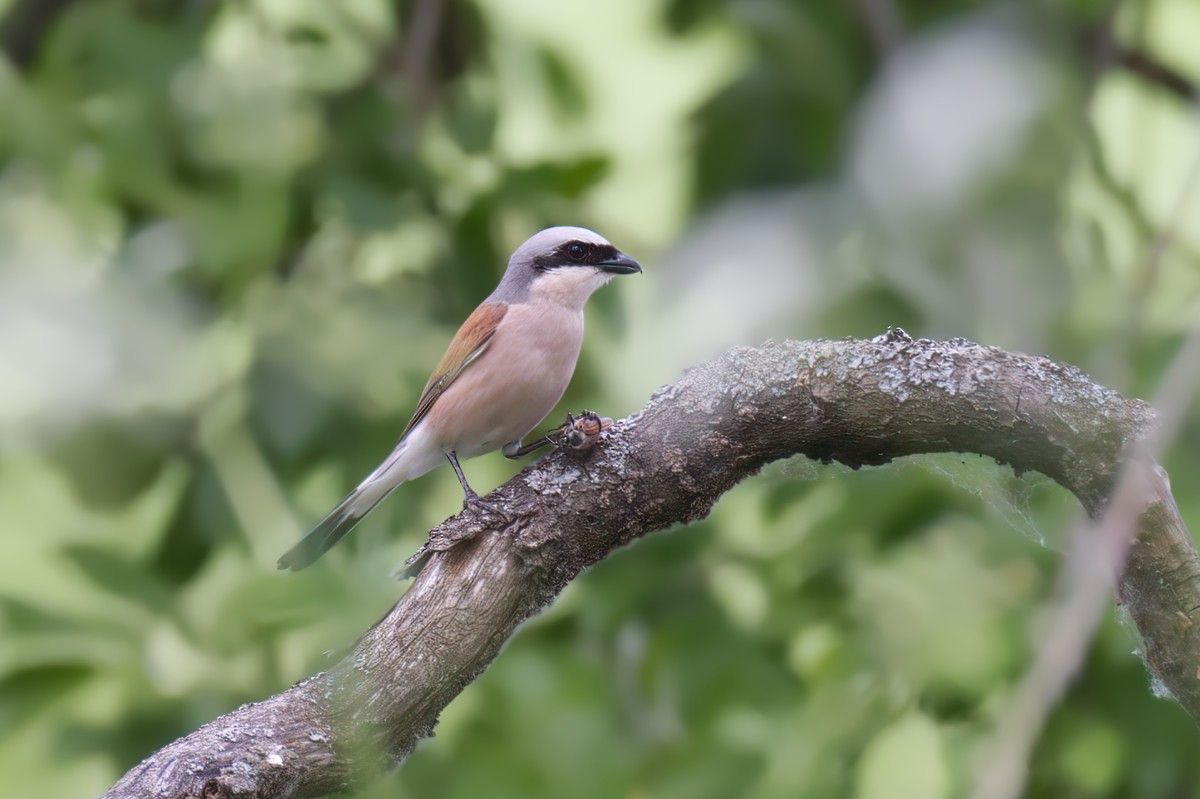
top-left (277, 227), bottom-right (642, 571)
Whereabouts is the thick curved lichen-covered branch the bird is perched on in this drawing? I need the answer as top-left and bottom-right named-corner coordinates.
top-left (106, 332), bottom-right (1200, 799)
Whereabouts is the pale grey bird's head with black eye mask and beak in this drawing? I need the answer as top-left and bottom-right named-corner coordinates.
top-left (493, 227), bottom-right (642, 307)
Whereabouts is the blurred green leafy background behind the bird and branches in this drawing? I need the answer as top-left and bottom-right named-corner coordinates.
top-left (0, 0), bottom-right (1200, 799)
